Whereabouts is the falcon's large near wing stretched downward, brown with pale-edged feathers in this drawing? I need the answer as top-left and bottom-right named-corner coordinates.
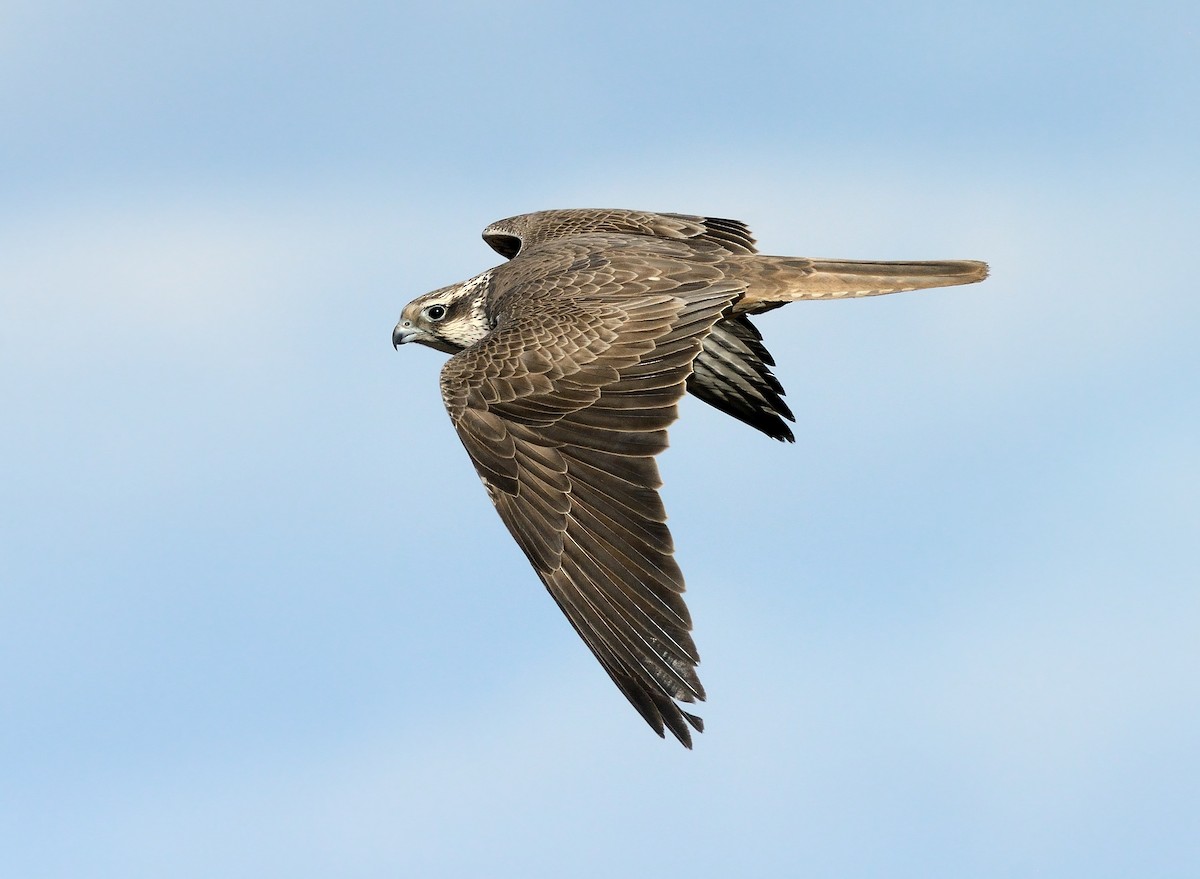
top-left (442, 263), bottom-right (742, 747)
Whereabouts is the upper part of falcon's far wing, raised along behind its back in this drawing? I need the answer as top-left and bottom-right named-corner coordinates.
top-left (484, 208), bottom-right (756, 259)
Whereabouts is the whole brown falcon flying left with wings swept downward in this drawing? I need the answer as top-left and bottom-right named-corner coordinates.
top-left (392, 209), bottom-right (988, 748)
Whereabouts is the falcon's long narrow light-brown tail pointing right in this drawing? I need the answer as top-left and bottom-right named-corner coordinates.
top-left (726, 256), bottom-right (988, 313)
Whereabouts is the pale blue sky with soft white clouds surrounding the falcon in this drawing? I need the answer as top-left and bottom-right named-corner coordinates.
top-left (0, 0), bottom-right (1200, 879)
